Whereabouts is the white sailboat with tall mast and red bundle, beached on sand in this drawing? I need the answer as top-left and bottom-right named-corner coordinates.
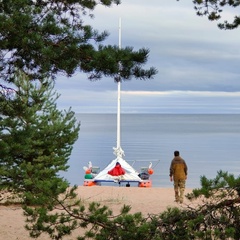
top-left (84, 18), bottom-right (153, 187)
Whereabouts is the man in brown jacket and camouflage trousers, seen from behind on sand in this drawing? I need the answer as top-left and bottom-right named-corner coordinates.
top-left (169, 151), bottom-right (188, 203)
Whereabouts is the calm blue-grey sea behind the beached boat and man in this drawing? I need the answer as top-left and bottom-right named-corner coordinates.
top-left (63, 114), bottom-right (240, 188)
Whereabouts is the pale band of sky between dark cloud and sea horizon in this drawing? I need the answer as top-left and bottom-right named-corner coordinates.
top-left (55, 85), bottom-right (240, 114)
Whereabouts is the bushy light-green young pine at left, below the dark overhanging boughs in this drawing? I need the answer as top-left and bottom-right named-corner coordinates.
top-left (0, 73), bottom-right (79, 205)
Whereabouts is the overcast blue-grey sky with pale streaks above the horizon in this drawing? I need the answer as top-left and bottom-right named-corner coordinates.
top-left (56, 0), bottom-right (240, 113)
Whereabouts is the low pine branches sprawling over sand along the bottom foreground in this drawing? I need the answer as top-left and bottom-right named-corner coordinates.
top-left (2, 171), bottom-right (236, 240)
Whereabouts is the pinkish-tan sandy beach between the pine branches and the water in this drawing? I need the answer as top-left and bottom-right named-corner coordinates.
top-left (0, 186), bottom-right (195, 240)
